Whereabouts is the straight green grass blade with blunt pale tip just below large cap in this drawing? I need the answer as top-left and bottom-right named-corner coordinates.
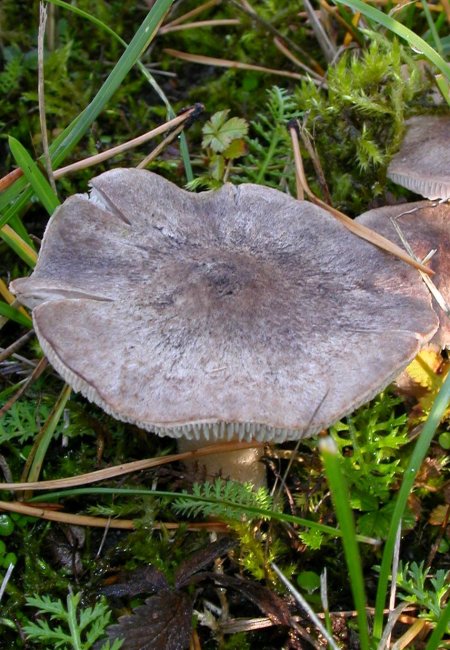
top-left (319, 437), bottom-right (370, 650)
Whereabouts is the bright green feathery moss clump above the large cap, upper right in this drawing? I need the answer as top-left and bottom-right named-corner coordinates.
top-left (294, 39), bottom-right (430, 215)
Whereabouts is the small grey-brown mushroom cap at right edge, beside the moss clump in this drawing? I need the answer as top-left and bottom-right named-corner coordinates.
top-left (387, 115), bottom-right (450, 200)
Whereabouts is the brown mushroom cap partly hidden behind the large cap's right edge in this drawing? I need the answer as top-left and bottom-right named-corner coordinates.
top-left (356, 201), bottom-right (450, 348)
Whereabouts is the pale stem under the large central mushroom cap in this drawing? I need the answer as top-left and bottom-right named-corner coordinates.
top-left (178, 438), bottom-right (266, 488)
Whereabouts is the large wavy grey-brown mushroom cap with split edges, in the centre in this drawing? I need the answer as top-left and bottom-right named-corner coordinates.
top-left (12, 169), bottom-right (438, 441)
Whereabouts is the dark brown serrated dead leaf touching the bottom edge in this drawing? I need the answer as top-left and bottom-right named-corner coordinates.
top-left (107, 589), bottom-right (193, 650)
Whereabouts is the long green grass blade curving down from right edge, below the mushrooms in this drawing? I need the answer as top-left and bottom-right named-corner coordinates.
top-left (373, 374), bottom-right (450, 641)
